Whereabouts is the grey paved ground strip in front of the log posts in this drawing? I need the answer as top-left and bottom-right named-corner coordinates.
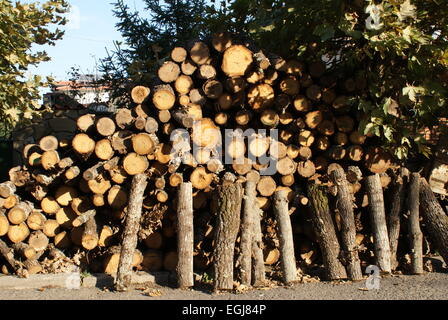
top-left (0, 272), bottom-right (448, 300)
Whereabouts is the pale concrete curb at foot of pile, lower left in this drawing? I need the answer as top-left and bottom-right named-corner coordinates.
top-left (0, 272), bottom-right (172, 290)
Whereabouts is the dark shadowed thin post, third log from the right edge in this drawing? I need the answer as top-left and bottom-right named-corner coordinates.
top-left (387, 168), bottom-right (409, 270)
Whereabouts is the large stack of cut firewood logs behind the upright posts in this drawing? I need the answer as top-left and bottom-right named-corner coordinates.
top-left (0, 33), bottom-right (444, 282)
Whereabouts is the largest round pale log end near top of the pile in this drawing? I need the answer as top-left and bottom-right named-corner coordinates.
top-left (221, 45), bottom-right (253, 77)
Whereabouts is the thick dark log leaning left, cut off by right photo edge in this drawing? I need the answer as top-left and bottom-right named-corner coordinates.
top-left (420, 178), bottom-right (448, 264)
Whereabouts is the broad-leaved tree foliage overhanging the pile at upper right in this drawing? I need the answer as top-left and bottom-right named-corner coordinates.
top-left (208, 0), bottom-right (448, 159)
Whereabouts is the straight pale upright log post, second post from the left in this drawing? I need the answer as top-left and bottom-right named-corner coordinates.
top-left (176, 182), bottom-right (194, 289)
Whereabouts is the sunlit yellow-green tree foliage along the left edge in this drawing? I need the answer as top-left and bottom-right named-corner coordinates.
top-left (0, 0), bottom-right (68, 135)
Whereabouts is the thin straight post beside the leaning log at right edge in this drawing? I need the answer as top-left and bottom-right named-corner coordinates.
top-left (407, 173), bottom-right (423, 274)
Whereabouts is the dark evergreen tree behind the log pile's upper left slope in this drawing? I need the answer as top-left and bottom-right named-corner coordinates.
top-left (100, 0), bottom-right (207, 103)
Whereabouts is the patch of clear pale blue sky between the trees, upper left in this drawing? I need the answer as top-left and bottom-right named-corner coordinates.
top-left (30, 0), bottom-right (143, 80)
